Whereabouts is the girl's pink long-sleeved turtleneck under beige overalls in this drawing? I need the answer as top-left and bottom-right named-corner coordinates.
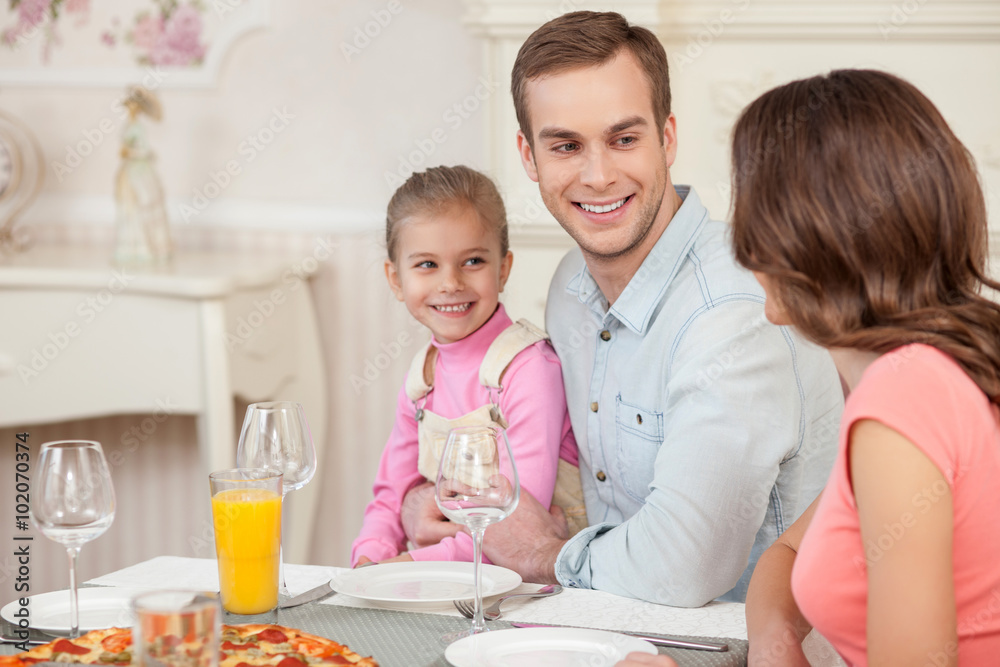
top-left (351, 305), bottom-right (577, 566)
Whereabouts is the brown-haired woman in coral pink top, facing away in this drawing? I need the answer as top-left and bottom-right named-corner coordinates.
top-left (626, 70), bottom-right (1000, 667)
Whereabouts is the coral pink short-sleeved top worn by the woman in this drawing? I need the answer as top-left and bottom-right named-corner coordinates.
top-left (792, 345), bottom-right (1000, 665)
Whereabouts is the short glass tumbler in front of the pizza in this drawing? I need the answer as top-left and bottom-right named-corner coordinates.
top-left (132, 591), bottom-right (222, 667)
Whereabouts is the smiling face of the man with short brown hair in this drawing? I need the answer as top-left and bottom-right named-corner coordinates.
top-left (518, 52), bottom-right (677, 259)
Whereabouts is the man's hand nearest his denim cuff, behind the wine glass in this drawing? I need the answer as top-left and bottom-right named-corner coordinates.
top-left (483, 490), bottom-right (569, 584)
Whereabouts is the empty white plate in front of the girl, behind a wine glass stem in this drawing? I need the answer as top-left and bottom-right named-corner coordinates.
top-left (330, 561), bottom-right (521, 608)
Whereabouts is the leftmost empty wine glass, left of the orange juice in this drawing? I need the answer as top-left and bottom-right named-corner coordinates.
top-left (31, 440), bottom-right (115, 637)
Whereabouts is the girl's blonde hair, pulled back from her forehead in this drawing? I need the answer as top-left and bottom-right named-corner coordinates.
top-left (385, 165), bottom-right (510, 262)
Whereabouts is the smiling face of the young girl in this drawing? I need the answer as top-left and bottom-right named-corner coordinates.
top-left (385, 206), bottom-right (514, 343)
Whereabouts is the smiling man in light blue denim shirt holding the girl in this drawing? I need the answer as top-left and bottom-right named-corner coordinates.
top-left (402, 12), bottom-right (843, 606)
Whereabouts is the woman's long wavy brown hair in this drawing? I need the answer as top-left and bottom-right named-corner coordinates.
top-left (732, 70), bottom-right (1000, 404)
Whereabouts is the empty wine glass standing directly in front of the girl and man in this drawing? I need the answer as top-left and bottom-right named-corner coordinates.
top-left (434, 426), bottom-right (521, 641)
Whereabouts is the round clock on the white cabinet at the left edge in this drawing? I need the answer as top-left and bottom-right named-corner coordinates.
top-left (0, 111), bottom-right (45, 251)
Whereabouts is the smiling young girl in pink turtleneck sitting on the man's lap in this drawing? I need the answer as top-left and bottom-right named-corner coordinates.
top-left (351, 166), bottom-right (586, 566)
